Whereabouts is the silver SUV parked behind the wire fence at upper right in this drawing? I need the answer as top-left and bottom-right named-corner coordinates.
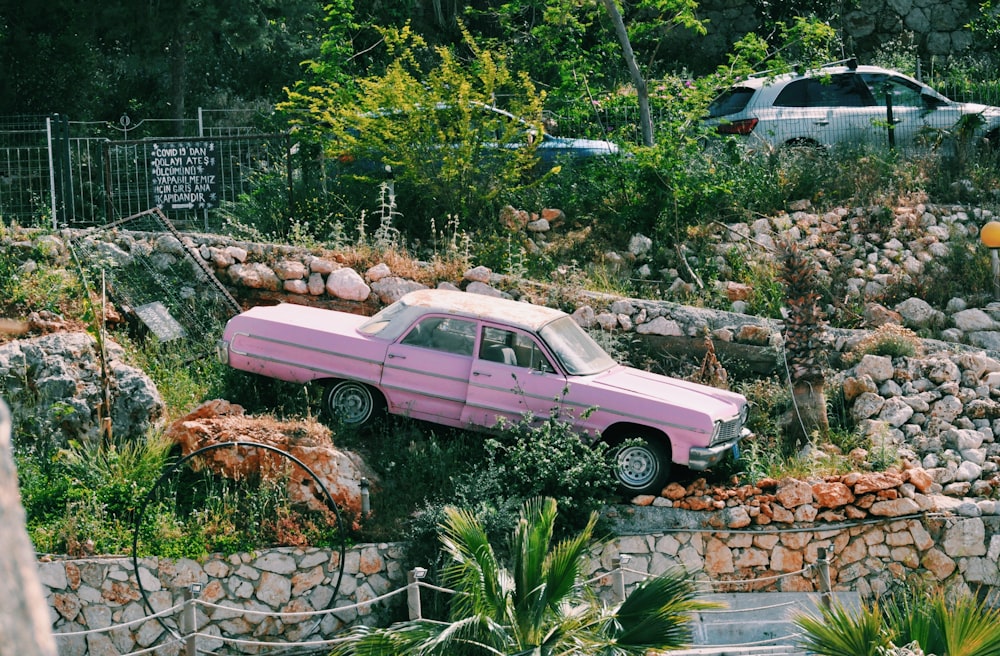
top-left (708, 60), bottom-right (1000, 150)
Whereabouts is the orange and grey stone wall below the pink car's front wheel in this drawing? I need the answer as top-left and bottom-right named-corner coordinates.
top-left (599, 469), bottom-right (1000, 598)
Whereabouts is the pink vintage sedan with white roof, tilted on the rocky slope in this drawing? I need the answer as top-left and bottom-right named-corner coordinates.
top-left (218, 290), bottom-right (748, 494)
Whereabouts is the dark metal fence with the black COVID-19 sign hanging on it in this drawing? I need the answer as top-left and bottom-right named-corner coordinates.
top-left (0, 110), bottom-right (291, 229)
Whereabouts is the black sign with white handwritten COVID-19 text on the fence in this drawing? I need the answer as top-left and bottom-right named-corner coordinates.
top-left (150, 141), bottom-right (219, 210)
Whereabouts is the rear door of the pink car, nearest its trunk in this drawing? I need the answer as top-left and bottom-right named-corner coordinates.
top-left (381, 315), bottom-right (477, 426)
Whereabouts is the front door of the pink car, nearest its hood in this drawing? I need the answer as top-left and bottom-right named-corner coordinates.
top-left (462, 323), bottom-right (567, 428)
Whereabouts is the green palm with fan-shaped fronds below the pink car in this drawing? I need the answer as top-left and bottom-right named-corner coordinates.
top-left (333, 498), bottom-right (714, 656)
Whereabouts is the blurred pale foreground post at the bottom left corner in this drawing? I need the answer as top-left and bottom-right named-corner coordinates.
top-left (0, 400), bottom-right (56, 656)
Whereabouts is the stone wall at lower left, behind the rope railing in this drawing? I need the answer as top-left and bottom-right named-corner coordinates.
top-left (39, 544), bottom-right (406, 656)
